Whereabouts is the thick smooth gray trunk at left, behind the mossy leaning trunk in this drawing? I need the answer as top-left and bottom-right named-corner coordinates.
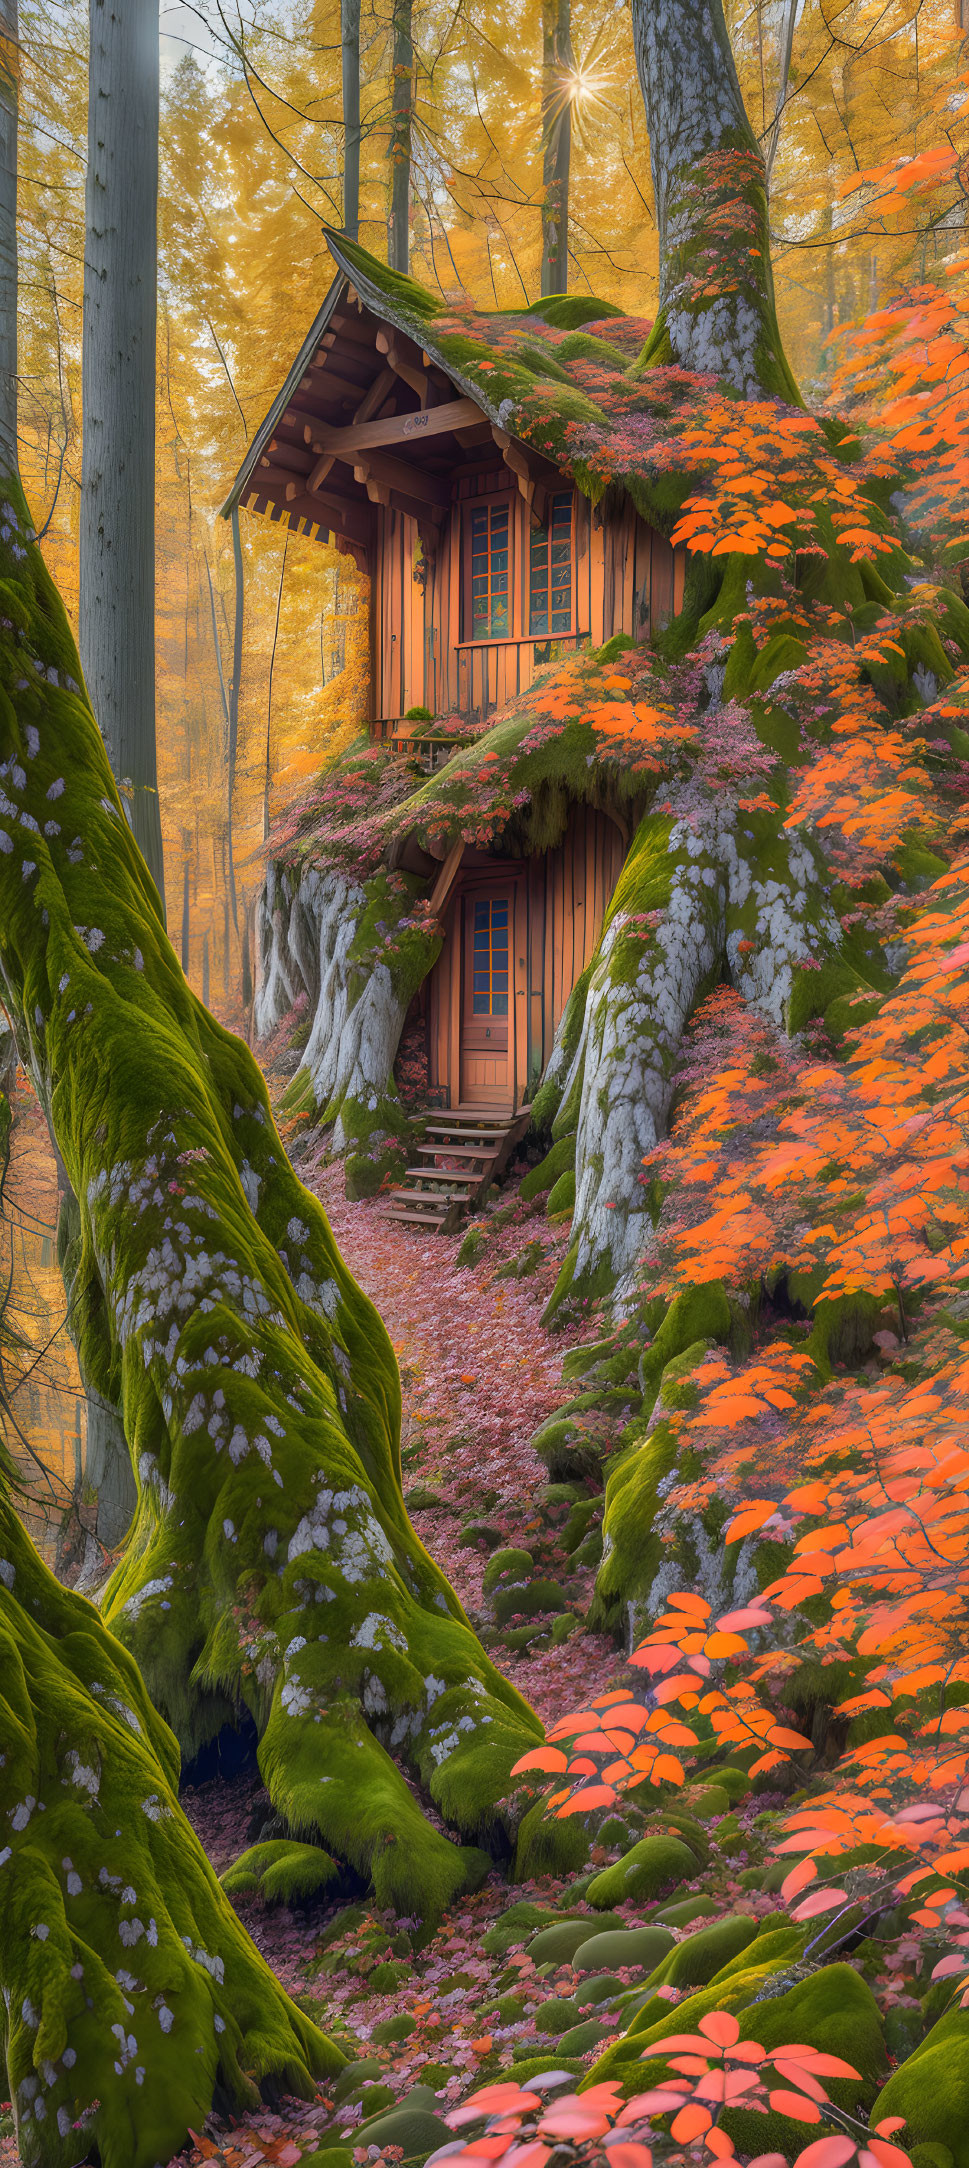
top-left (80, 0), bottom-right (165, 898)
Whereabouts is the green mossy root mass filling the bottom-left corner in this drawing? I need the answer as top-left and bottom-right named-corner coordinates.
top-left (0, 1479), bottom-right (343, 2168)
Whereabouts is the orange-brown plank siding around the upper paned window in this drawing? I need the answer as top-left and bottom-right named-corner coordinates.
top-left (371, 462), bottom-right (685, 718)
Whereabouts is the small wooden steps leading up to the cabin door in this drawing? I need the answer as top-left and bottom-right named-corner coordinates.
top-left (384, 1106), bottom-right (531, 1234)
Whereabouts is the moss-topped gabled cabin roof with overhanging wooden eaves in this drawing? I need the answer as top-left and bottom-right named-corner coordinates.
top-left (221, 232), bottom-right (650, 551)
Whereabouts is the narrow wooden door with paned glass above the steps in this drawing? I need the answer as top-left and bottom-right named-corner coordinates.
top-left (460, 878), bottom-right (516, 1110)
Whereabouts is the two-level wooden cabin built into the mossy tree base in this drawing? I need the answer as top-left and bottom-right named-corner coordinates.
top-left (223, 236), bottom-right (685, 1110)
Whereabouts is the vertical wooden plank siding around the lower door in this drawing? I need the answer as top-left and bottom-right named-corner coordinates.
top-left (427, 806), bottom-right (626, 1106)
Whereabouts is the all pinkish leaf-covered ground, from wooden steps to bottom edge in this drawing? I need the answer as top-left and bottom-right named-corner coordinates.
top-left (166, 1136), bottom-right (646, 2168)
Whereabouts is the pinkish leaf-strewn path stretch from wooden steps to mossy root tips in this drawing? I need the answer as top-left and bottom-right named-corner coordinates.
top-left (297, 1145), bottom-right (616, 1724)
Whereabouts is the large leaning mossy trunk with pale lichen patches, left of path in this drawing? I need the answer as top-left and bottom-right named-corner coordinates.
top-left (0, 483), bottom-right (540, 1914)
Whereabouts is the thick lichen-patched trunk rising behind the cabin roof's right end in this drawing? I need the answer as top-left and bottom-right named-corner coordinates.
top-left (633, 0), bottom-right (800, 405)
